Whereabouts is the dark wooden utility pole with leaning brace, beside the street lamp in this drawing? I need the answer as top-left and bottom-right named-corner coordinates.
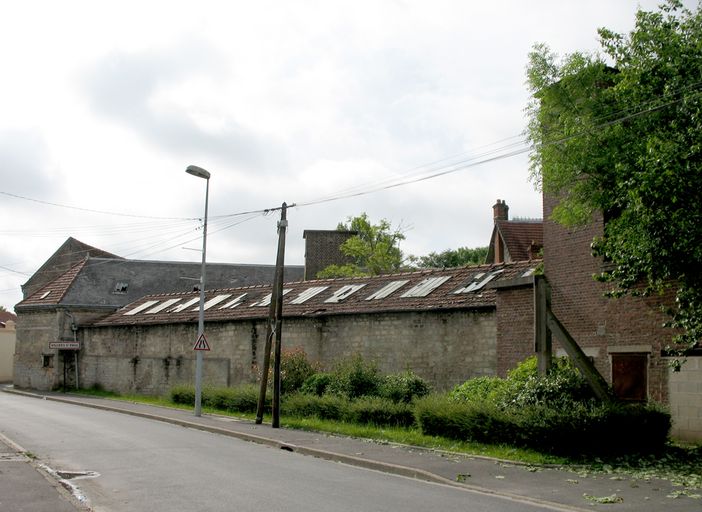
top-left (256, 203), bottom-right (288, 428)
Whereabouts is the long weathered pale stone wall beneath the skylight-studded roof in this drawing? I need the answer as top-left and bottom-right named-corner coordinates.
top-left (79, 310), bottom-right (497, 394)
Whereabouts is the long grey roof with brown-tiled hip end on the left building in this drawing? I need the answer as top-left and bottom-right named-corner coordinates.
top-left (15, 258), bottom-right (304, 311)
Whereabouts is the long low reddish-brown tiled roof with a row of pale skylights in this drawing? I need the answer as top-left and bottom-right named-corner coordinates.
top-left (93, 260), bottom-right (540, 326)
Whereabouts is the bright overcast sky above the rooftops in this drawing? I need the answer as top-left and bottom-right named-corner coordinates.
top-left (0, 0), bottom-right (696, 311)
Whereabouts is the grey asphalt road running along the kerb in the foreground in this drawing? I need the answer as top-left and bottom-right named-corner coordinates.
top-left (0, 393), bottom-right (560, 512)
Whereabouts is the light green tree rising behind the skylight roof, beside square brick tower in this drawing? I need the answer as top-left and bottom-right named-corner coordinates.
top-left (317, 212), bottom-right (405, 278)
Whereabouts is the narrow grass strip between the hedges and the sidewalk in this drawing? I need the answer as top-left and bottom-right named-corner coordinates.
top-left (64, 389), bottom-right (702, 492)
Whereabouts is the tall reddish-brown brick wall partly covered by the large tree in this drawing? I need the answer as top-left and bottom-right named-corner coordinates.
top-left (544, 197), bottom-right (673, 402)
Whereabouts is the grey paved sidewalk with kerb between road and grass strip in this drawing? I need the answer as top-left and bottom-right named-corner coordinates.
top-left (0, 388), bottom-right (702, 512)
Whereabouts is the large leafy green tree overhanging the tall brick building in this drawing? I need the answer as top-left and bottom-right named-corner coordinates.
top-left (527, 0), bottom-right (702, 347)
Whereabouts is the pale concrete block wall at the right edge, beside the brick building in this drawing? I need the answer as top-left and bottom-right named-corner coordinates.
top-left (669, 357), bottom-right (702, 441)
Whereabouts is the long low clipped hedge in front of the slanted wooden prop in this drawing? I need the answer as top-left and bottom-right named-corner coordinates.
top-left (415, 397), bottom-right (671, 457)
